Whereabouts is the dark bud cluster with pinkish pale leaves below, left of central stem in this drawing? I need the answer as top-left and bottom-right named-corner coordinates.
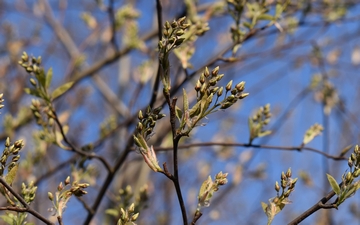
top-left (134, 107), bottom-right (165, 172)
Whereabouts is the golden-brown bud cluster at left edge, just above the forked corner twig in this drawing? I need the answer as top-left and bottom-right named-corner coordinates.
top-left (0, 137), bottom-right (24, 176)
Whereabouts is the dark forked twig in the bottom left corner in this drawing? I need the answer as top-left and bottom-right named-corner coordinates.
top-left (0, 177), bottom-right (54, 225)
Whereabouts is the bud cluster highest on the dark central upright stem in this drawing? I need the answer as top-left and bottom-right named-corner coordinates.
top-left (159, 17), bottom-right (190, 53)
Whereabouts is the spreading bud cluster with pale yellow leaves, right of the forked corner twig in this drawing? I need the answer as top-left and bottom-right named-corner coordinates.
top-left (48, 176), bottom-right (89, 217)
